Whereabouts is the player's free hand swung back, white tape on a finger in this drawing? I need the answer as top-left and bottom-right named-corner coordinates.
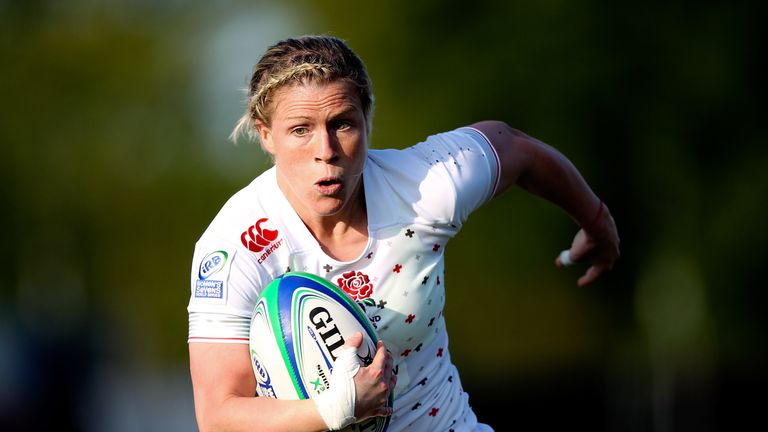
top-left (555, 203), bottom-right (619, 286)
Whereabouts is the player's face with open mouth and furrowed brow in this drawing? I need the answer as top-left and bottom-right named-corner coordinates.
top-left (256, 81), bottom-right (367, 222)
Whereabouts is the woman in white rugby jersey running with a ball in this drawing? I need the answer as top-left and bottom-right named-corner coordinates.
top-left (188, 36), bottom-right (619, 431)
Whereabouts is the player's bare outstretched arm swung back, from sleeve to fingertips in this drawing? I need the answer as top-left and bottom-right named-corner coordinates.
top-left (471, 121), bottom-right (619, 286)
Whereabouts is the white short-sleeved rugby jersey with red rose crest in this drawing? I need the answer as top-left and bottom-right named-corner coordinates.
top-left (188, 127), bottom-right (499, 431)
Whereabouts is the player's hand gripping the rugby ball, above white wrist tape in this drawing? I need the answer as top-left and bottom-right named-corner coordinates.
top-left (345, 332), bottom-right (397, 422)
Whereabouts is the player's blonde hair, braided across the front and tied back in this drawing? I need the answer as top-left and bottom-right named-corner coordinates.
top-left (230, 36), bottom-right (373, 141)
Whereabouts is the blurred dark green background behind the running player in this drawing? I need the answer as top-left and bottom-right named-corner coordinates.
top-left (0, 0), bottom-right (768, 431)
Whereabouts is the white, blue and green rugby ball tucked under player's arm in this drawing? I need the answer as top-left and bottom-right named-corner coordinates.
top-left (249, 272), bottom-right (392, 431)
